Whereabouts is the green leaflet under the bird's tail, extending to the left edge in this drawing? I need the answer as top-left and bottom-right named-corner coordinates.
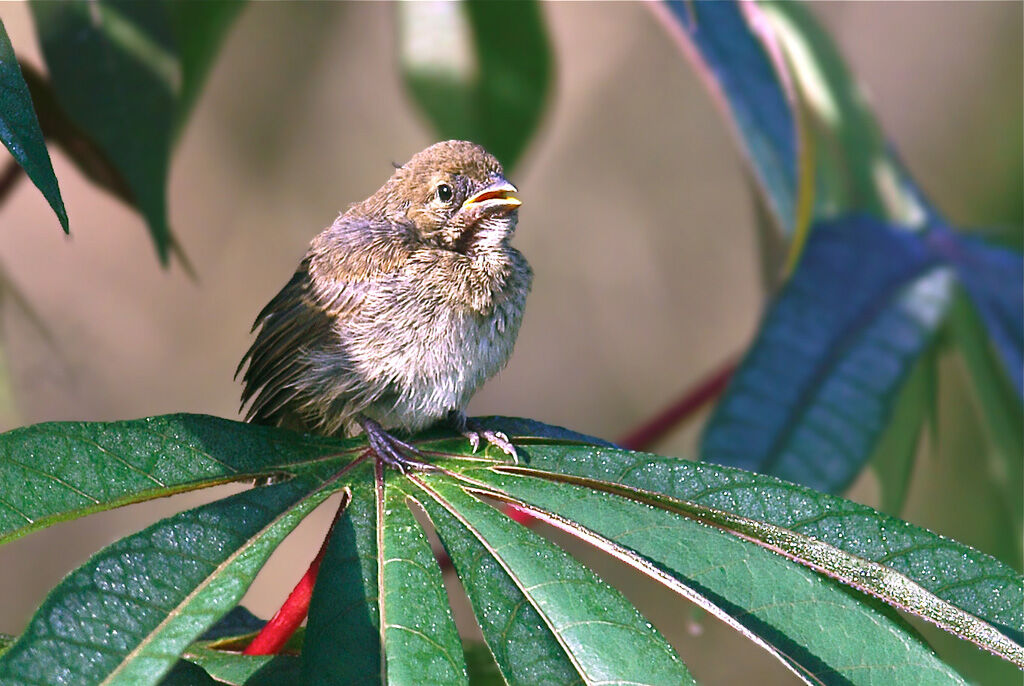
top-left (0, 415), bottom-right (361, 543)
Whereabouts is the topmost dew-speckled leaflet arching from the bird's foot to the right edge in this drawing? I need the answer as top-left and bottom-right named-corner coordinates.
top-left (477, 436), bottom-right (1024, 646)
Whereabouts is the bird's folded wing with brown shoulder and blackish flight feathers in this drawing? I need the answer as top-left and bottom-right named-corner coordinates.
top-left (234, 215), bottom-right (413, 428)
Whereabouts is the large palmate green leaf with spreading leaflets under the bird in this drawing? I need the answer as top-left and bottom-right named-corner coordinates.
top-left (8, 416), bottom-right (1024, 686)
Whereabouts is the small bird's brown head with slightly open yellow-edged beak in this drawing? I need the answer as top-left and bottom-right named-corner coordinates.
top-left (369, 140), bottom-right (522, 253)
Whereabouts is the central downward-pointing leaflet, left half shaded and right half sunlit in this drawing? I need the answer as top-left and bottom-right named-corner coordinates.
top-left (303, 465), bottom-right (467, 684)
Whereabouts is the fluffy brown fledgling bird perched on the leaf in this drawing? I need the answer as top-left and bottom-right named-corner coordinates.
top-left (236, 140), bottom-right (532, 471)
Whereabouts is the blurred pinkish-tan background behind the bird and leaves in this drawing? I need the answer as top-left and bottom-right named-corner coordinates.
top-left (0, 2), bottom-right (1024, 684)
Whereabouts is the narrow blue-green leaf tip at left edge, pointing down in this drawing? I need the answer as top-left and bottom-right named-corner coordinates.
top-left (0, 22), bottom-right (69, 233)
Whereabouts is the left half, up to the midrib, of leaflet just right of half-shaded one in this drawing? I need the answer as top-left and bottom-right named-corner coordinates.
top-left (420, 483), bottom-right (582, 686)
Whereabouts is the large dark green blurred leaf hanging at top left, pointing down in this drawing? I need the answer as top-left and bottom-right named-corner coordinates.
top-left (32, 2), bottom-right (181, 262)
